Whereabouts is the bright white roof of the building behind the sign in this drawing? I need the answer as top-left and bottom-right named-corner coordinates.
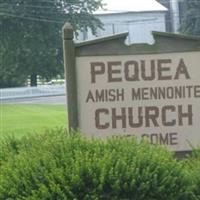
top-left (94, 0), bottom-right (167, 15)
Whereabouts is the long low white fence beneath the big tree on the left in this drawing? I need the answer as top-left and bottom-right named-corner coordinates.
top-left (0, 84), bottom-right (66, 100)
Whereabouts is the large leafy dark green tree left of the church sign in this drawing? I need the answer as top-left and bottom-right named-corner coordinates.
top-left (0, 0), bottom-right (102, 87)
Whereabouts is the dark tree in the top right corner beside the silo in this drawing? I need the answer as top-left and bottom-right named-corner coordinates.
top-left (180, 0), bottom-right (200, 36)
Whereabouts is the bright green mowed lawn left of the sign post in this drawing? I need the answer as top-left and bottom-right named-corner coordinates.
top-left (0, 104), bottom-right (67, 138)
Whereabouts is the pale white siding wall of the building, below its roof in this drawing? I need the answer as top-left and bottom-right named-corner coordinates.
top-left (78, 12), bottom-right (166, 43)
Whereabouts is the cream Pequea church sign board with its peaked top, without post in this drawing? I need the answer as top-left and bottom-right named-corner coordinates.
top-left (62, 22), bottom-right (200, 151)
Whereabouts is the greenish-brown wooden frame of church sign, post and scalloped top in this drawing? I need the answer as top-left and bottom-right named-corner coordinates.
top-left (63, 23), bottom-right (200, 157)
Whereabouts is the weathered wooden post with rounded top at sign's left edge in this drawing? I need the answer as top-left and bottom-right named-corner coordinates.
top-left (62, 23), bottom-right (78, 131)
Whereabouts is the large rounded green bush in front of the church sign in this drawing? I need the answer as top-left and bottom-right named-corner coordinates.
top-left (0, 131), bottom-right (198, 200)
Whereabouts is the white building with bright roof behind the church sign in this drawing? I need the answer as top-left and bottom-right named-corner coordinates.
top-left (79, 0), bottom-right (167, 43)
